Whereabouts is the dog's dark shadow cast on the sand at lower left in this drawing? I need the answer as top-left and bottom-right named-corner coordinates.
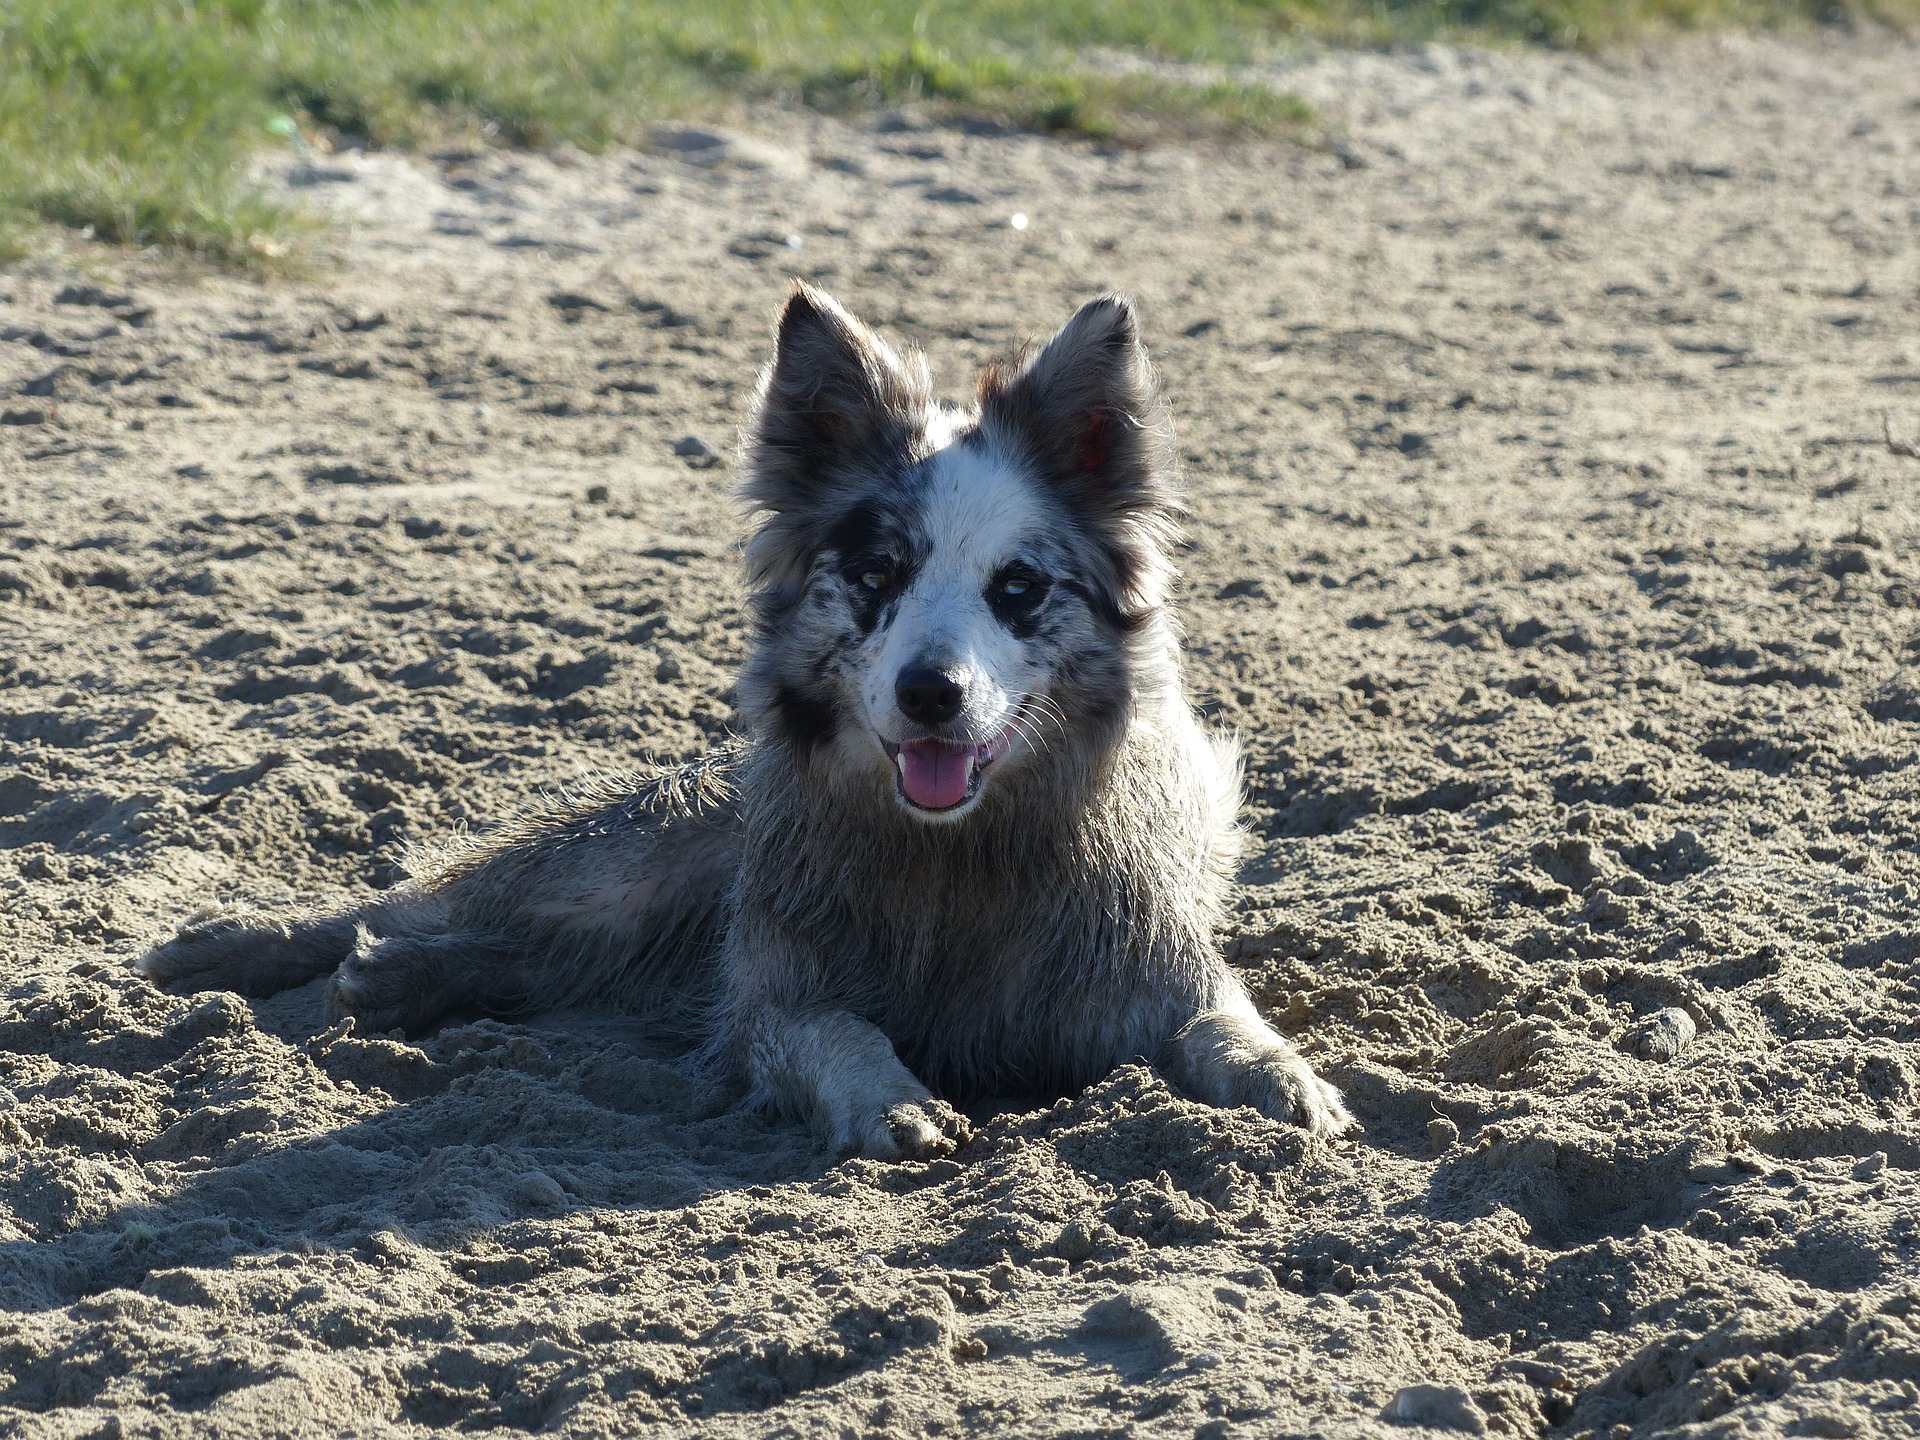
top-left (0, 975), bottom-right (835, 1309)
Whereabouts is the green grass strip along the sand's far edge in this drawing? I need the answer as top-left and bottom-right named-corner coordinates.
top-left (0, 0), bottom-right (1920, 263)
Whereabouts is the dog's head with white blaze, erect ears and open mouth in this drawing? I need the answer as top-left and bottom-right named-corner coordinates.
top-left (741, 286), bottom-right (1177, 820)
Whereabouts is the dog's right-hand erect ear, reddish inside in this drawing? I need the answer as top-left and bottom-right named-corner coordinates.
top-left (979, 296), bottom-right (1177, 516)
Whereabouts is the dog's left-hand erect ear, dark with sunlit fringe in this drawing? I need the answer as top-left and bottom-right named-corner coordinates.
top-left (741, 282), bottom-right (933, 513)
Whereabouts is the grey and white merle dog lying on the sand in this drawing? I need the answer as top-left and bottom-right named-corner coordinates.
top-left (138, 284), bottom-right (1354, 1158)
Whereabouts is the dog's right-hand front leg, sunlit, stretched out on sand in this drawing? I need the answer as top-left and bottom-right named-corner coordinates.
top-left (1167, 985), bottom-right (1359, 1135)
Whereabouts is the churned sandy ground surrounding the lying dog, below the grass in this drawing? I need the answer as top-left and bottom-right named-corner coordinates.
top-left (0, 38), bottom-right (1920, 1440)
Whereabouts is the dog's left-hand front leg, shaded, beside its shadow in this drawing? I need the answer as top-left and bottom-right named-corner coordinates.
top-left (735, 1004), bottom-right (972, 1160)
